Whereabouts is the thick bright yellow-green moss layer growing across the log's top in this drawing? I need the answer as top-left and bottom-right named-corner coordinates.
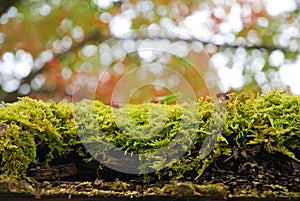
top-left (0, 91), bottom-right (300, 182)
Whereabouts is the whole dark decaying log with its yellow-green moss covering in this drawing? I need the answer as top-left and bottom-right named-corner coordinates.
top-left (0, 91), bottom-right (300, 199)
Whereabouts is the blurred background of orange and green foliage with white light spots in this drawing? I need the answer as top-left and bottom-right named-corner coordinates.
top-left (0, 0), bottom-right (300, 103)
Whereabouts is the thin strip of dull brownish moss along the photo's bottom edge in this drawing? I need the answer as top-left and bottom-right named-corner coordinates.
top-left (0, 180), bottom-right (300, 200)
